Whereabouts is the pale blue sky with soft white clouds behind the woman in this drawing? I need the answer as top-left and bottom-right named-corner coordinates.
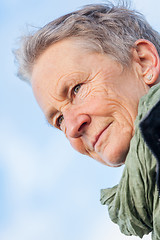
top-left (0, 0), bottom-right (160, 240)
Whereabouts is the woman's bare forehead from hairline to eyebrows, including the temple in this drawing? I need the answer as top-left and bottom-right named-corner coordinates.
top-left (31, 39), bottom-right (121, 115)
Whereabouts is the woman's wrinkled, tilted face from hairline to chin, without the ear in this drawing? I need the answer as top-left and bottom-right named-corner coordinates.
top-left (32, 40), bottom-right (148, 166)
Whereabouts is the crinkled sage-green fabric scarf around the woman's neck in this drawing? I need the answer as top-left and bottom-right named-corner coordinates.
top-left (101, 84), bottom-right (160, 240)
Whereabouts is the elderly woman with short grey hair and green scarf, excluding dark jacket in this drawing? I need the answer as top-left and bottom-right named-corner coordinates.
top-left (16, 2), bottom-right (160, 240)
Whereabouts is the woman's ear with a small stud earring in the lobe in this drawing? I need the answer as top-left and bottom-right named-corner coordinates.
top-left (133, 39), bottom-right (160, 85)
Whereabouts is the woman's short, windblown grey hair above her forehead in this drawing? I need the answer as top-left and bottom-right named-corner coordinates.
top-left (14, 3), bottom-right (160, 81)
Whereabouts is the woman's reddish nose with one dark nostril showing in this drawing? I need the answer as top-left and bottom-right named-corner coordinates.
top-left (63, 110), bottom-right (91, 138)
